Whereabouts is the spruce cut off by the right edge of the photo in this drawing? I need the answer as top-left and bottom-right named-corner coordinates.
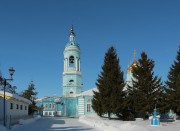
top-left (165, 46), bottom-right (180, 115)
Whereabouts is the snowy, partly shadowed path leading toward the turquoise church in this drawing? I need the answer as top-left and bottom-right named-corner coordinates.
top-left (10, 117), bottom-right (98, 131)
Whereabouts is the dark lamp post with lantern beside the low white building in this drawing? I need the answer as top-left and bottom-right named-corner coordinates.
top-left (3, 67), bottom-right (15, 126)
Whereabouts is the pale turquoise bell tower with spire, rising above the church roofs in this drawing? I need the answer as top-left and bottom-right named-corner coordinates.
top-left (62, 26), bottom-right (82, 97)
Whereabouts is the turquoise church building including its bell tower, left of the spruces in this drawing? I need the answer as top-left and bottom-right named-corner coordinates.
top-left (36, 26), bottom-right (96, 117)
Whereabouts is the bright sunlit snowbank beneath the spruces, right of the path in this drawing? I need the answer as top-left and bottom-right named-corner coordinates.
top-left (79, 114), bottom-right (180, 131)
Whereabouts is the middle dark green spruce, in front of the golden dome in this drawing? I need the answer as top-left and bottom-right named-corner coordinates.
top-left (128, 52), bottom-right (163, 117)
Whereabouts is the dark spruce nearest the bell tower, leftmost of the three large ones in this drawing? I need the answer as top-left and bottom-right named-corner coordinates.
top-left (92, 47), bottom-right (125, 119)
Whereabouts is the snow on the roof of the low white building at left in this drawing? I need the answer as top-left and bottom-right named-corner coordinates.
top-left (0, 90), bottom-right (32, 104)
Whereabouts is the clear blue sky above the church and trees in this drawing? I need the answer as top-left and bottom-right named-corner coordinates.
top-left (0, 0), bottom-right (180, 97)
